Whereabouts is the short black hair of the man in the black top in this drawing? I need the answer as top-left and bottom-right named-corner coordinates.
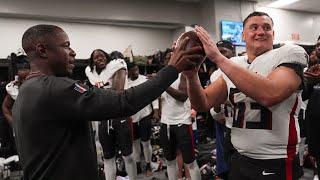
top-left (22, 24), bottom-right (62, 55)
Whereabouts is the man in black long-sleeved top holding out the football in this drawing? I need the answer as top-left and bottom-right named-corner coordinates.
top-left (13, 25), bottom-right (201, 180)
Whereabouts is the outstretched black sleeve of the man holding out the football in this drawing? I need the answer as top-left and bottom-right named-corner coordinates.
top-left (48, 66), bottom-right (178, 121)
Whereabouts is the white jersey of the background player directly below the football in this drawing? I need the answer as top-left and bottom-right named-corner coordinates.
top-left (161, 74), bottom-right (191, 125)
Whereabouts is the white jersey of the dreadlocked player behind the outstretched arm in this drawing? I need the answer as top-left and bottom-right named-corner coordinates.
top-left (85, 59), bottom-right (127, 89)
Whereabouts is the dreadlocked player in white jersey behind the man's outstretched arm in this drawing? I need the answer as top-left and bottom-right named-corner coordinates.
top-left (85, 49), bottom-right (137, 180)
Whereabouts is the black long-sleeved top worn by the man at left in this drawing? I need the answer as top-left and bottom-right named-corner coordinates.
top-left (13, 66), bottom-right (178, 180)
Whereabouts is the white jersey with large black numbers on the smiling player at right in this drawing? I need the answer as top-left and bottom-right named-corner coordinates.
top-left (223, 45), bottom-right (308, 159)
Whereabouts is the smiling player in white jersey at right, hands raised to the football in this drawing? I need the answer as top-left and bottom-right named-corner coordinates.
top-left (184, 12), bottom-right (308, 180)
